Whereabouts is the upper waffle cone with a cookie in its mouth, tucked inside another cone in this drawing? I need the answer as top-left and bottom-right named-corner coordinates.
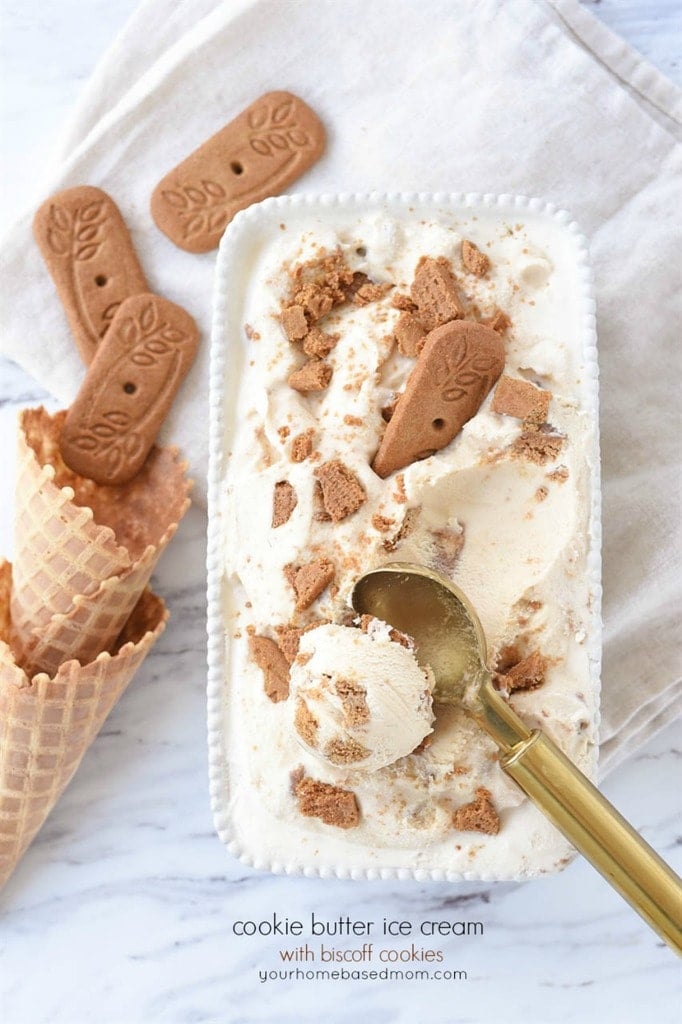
top-left (11, 408), bottom-right (191, 676)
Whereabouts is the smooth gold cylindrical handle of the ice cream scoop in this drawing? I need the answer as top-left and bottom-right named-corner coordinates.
top-left (500, 730), bottom-right (682, 954)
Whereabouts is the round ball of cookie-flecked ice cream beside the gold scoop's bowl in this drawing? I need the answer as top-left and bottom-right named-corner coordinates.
top-left (290, 621), bottom-right (433, 771)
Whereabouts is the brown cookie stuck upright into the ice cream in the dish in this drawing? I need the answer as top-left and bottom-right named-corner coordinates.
top-left (372, 319), bottom-right (505, 477)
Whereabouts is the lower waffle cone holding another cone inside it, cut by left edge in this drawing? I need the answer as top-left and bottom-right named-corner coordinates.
top-left (0, 562), bottom-right (168, 888)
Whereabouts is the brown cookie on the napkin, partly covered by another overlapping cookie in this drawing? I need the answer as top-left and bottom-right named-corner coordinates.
top-left (33, 185), bottom-right (148, 366)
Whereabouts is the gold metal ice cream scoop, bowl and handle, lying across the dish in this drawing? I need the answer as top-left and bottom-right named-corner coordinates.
top-left (352, 562), bottom-right (682, 953)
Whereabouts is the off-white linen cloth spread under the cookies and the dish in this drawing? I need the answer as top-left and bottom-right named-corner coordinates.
top-left (0, 0), bottom-right (682, 773)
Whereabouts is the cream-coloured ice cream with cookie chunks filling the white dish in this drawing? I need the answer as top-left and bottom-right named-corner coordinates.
top-left (214, 193), bottom-right (598, 878)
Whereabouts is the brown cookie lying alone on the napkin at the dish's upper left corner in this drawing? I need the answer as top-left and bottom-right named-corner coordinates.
top-left (152, 92), bottom-right (326, 253)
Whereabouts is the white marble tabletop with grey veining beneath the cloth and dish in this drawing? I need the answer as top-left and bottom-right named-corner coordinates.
top-left (0, 0), bottom-right (682, 1024)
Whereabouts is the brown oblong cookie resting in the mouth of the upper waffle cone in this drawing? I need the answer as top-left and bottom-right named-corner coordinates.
top-left (59, 294), bottom-right (199, 485)
